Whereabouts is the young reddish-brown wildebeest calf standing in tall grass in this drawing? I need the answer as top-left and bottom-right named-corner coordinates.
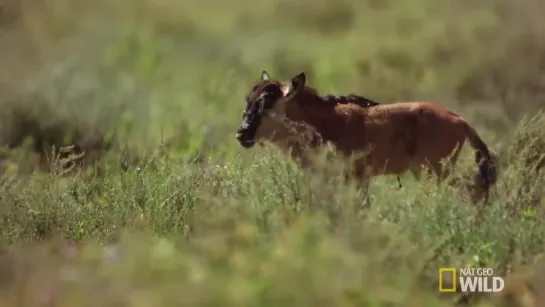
top-left (236, 71), bottom-right (497, 205)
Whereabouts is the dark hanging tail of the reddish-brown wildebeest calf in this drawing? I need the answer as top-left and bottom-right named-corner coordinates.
top-left (467, 124), bottom-right (498, 192)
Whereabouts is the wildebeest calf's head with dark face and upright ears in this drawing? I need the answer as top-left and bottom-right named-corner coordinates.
top-left (236, 71), bottom-right (306, 148)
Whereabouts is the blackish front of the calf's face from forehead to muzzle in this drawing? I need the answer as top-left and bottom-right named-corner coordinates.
top-left (237, 80), bottom-right (282, 148)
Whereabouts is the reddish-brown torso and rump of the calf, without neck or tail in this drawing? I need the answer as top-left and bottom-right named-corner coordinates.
top-left (336, 102), bottom-right (466, 173)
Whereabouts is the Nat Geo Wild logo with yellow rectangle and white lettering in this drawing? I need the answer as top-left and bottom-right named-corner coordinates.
top-left (439, 268), bottom-right (504, 293)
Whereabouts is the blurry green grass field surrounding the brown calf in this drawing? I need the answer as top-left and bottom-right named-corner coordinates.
top-left (0, 0), bottom-right (545, 307)
